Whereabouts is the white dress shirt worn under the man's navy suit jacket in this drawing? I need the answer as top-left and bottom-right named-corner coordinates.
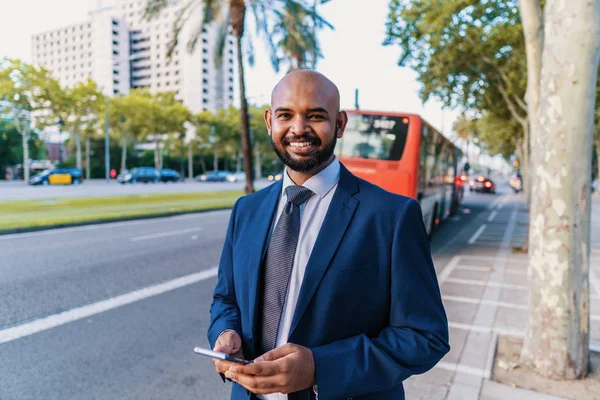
top-left (258, 157), bottom-right (340, 400)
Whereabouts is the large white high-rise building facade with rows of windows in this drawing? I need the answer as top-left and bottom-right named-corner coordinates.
top-left (32, 0), bottom-right (237, 113)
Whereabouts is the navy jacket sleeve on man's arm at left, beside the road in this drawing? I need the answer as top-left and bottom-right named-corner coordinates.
top-left (208, 200), bottom-right (242, 349)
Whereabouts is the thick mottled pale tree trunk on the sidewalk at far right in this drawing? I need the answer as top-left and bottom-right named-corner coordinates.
top-left (521, 0), bottom-right (600, 379)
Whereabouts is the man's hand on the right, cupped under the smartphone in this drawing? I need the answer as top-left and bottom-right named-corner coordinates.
top-left (225, 343), bottom-right (315, 394)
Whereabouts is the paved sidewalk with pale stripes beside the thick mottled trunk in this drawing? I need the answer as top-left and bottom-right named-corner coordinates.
top-left (405, 193), bottom-right (600, 400)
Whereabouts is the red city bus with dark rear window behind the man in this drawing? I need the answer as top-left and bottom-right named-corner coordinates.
top-left (336, 110), bottom-right (463, 235)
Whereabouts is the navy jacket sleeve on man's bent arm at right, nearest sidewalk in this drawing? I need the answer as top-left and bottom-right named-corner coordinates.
top-left (311, 199), bottom-right (450, 400)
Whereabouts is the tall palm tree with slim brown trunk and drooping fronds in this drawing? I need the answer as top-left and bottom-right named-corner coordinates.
top-left (145, 0), bottom-right (330, 193)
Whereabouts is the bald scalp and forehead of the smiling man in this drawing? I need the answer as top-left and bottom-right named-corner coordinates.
top-left (271, 70), bottom-right (340, 113)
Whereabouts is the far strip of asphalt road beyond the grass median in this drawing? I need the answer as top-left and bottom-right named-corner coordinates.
top-left (0, 178), bottom-right (272, 201)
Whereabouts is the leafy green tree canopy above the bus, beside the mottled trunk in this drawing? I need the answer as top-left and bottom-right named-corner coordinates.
top-left (385, 0), bottom-right (529, 175)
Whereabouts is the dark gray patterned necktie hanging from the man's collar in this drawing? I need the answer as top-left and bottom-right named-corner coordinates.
top-left (260, 186), bottom-right (313, 353)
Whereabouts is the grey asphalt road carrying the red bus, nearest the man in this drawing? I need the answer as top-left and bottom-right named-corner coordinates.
top-left (0, 188), bottom-right (500, 400)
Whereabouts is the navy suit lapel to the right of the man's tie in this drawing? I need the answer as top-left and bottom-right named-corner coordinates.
top-left (290, 165), bottom-right (359, 337)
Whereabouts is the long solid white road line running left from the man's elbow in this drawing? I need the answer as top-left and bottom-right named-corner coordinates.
top-left (0, 267), bottom-right (218, 344)
